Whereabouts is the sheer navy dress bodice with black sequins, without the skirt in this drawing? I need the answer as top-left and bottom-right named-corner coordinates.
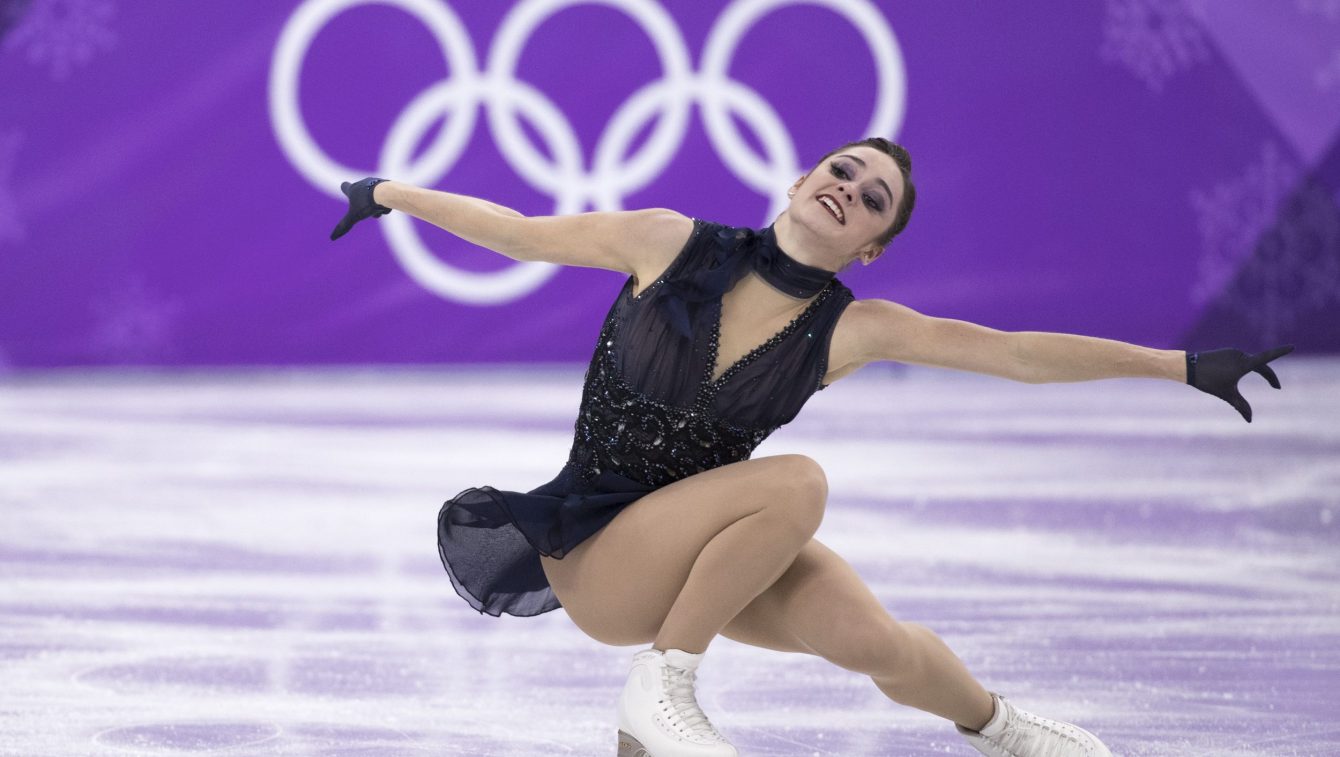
top-left (568, 221), bottom-right (851, 488)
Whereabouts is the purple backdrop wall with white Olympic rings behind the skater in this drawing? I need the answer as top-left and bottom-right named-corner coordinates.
top-left (0, 0), bottom-right (1340, 368)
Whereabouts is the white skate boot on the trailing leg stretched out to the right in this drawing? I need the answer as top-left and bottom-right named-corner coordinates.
top-left (954, 691), bottom-right (1112, 757)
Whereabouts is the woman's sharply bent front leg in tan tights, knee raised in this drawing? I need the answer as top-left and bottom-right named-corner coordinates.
top-left (541, 454), bottom-right (828, 652)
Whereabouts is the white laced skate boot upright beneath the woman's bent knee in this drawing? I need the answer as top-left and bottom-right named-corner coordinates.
top-left (619, 648), bottom-right (740, 757)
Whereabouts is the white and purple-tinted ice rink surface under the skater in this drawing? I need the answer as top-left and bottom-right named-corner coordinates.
top-left (0, 355), bottom-right (1340, 757)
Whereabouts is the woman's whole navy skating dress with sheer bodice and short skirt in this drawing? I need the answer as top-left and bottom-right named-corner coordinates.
top-left (438, 218), bottom-right (852, 616)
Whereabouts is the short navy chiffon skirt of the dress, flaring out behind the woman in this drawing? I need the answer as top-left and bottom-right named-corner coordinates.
top-left (437, 466), bottom-right (653, 618)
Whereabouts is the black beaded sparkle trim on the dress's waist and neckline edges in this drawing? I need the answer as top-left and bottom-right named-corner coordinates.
top-left (568, 271), bottom-right (833, 488)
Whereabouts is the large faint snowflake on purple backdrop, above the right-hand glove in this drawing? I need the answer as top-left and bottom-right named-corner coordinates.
top-left (1191, 142), bottom-right (1340, 340)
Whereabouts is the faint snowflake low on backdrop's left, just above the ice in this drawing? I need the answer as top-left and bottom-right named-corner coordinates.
top-left (90, 275), bottom-right (181, 360)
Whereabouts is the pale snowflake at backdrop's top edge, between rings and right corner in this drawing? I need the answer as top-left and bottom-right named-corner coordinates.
top-left (1099, 0), bottom-right (1210, 92)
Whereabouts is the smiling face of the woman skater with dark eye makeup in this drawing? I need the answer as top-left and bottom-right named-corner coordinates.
top-left (787, 145), bottom-right (903, 264)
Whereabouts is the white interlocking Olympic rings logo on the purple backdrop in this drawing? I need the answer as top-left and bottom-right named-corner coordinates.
top-left (269, 0), bottom-right (906, 304)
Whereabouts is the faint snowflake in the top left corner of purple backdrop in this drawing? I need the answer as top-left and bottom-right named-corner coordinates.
top-left (4, 0), bottom-right (117, 80)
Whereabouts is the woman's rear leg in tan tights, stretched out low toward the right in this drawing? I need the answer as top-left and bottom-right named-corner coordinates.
top-left (722, 539), bottom-right (994, 730)
